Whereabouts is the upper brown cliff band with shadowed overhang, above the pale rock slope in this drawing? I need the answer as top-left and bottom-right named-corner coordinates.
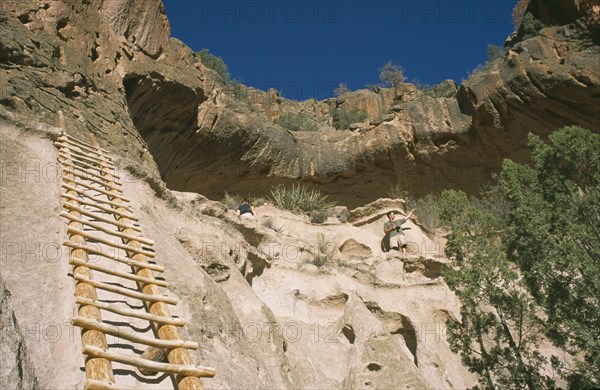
top-left (0, 0), bottom-right (600, 206)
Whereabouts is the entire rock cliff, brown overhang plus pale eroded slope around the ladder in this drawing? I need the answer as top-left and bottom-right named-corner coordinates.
top-left (0, 0), bottom-right (600, 388)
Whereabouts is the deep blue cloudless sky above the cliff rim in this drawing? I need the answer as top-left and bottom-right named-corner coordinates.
top-left (163, 0), bottom-right (516, 100)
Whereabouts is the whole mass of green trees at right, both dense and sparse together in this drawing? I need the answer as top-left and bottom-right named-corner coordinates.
top-left (440, 127), bottom-right (600, 389)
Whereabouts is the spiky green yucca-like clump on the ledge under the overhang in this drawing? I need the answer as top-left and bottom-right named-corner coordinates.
top-left (271, 185), bottom-right (335, 213)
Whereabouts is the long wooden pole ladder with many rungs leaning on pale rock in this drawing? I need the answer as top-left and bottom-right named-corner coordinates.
top-left (55, 132), bottom-right (215, 389)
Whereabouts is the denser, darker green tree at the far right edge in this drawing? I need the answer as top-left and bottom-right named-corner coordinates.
top-left (500, 126), bottom-right (600, 387)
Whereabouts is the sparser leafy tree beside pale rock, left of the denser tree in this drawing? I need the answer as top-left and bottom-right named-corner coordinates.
top-left (441, 191), bottom-right (554, 389)
